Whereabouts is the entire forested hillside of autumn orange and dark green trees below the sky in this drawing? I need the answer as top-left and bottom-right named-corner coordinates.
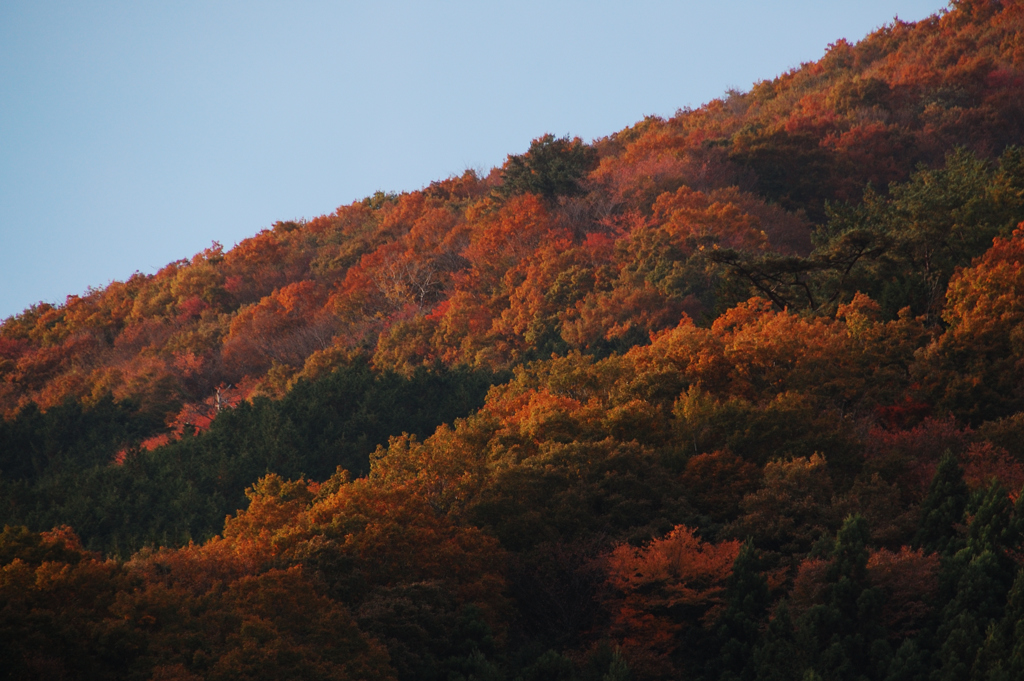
top-left (0, 0), bottom-right (1024, 681)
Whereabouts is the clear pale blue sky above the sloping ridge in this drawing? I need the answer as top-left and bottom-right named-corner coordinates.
top-left (0, 0), bottom-right (946, 320)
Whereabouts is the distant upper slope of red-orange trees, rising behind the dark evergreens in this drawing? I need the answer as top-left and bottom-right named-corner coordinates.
top-left (6, 3), bottom-right (1024, 426)
